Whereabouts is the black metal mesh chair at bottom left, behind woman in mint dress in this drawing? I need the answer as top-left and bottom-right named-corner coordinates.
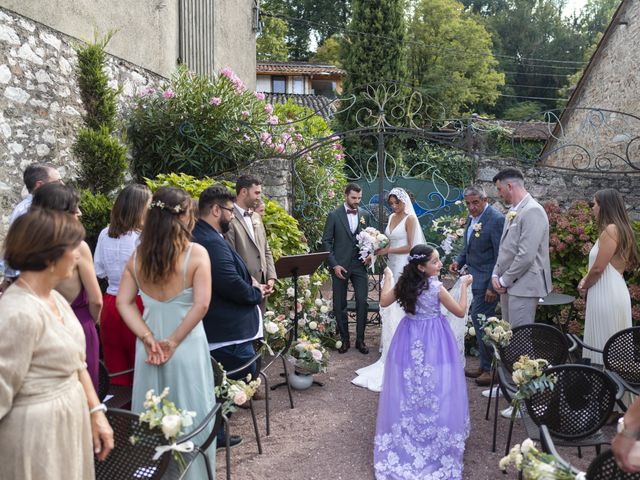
top-left (95, 403), bottom-right (221, 480)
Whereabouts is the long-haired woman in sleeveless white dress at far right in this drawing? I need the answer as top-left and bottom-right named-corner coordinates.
top-left (578, 188), bottom-right (639, 365)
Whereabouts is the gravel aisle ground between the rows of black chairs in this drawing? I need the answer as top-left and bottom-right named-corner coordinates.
top-left (217, 326), bottom-right (613, 480)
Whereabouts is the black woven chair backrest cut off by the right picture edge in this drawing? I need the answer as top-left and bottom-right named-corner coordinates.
top-left (602, 327), bottom-right (640, 386)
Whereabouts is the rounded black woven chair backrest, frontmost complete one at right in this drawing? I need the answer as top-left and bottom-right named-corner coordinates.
top-left (525, 365), bottom-right (617, 440)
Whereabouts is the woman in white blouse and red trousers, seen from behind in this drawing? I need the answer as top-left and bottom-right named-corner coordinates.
top-left (93, 185), bottom-right (151, 386)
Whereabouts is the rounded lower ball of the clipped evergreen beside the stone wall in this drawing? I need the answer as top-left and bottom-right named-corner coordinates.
top-left (73, 125), bottom-right (128, 193)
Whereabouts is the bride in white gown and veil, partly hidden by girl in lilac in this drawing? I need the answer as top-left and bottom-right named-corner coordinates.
top-left (351, 188), bottom-right (426, 392)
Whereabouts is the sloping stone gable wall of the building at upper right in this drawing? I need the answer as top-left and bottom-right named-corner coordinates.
top-left (544, 0), bottom-right (640, 170)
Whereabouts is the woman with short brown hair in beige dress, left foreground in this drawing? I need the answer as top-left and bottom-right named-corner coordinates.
top-left (0, 208), bottom-right (113, 480)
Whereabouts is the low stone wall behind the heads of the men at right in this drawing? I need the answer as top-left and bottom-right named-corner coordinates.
top-left (476, 159), bottom-right (640, 220)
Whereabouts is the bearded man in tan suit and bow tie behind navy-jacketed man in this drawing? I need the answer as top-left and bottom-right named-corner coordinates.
top-left (225, 175), bottom-right (278, 295)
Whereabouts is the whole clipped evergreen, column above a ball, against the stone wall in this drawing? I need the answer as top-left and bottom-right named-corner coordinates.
top-left (73, 31), bottom-right (127, 194)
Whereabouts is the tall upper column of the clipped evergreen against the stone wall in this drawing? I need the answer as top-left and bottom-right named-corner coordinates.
top-left (75, 31), bottom-right (119, 130)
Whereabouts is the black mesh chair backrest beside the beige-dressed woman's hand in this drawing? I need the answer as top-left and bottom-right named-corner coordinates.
top-left (95, 408), bottom-right (171, 480)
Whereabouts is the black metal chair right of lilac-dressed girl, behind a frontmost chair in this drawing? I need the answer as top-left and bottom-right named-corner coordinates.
top-left (485, 323), bottom-right (569, 453)
